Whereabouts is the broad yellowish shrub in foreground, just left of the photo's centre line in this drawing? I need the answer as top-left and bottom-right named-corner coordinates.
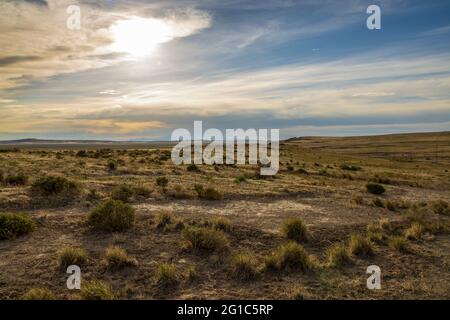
top-left (182, 227), bottom-right (229, 251)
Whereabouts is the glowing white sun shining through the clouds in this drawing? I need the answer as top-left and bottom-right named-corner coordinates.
top-left (110, 17), bottom-right (174, 57)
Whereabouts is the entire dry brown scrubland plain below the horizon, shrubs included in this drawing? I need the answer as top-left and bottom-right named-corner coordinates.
top-left (0, 133), bottom-right (450, 299)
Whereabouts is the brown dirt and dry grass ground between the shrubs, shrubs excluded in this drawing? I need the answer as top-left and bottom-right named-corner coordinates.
top-left (0, 133), bottom-right (450, 299)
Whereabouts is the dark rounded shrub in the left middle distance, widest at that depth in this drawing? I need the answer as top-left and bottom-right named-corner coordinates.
top-left (31, 176), bottom-right (79, 196)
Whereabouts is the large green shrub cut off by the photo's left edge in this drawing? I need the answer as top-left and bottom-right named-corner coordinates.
top-left (0, 213), bottom-right (36, 240)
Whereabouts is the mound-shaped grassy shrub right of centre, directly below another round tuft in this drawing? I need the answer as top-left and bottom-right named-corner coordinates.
top-left (265, 241), bottom-right (313, 271)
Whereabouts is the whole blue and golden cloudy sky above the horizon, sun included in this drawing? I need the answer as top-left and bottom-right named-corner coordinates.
top-left (0, 0), bottom-right (450, 140)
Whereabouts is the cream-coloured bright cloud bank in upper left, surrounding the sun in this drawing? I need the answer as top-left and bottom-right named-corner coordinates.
top-left (0, 0), bottom-right (211, 90)
